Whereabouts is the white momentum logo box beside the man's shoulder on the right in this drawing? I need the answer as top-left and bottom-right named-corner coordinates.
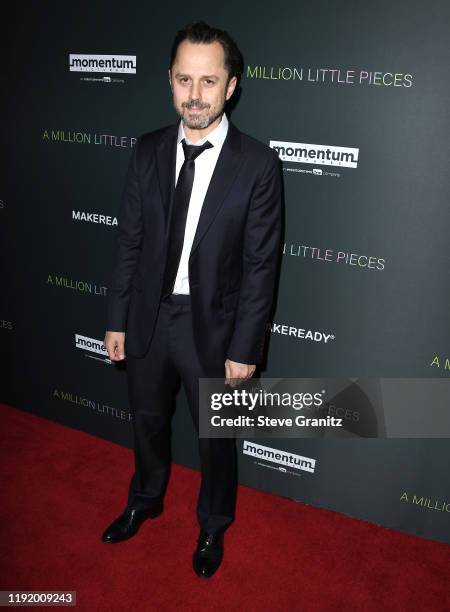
top-left (269, 140), bottom-right (359, 168)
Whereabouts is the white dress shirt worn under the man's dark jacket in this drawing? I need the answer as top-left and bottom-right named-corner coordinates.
top-left (173, 113), bottom-right (228, 294)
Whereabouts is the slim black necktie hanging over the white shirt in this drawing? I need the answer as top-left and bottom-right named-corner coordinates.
top-left (162, 138), bottom-right (213, 297)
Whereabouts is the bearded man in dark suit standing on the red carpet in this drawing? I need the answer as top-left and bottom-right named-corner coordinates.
top-left (102, 22), bottom-right (281, 577)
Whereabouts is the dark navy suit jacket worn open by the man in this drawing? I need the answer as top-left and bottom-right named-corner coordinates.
top-left (107, 114), bottom-right (282, 376)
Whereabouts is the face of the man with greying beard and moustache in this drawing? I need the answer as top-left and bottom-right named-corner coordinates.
top-left (169, 40), bottom-right (237, 129)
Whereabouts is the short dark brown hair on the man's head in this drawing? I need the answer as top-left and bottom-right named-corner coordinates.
top-left (169, 21), bottom-right (244, 84)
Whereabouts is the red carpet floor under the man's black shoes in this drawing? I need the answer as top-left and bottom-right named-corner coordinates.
top-left (0, 406), bottom-right (450, 612)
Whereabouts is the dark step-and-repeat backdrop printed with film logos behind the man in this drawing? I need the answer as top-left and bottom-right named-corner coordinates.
top-left (0, 0), bottom-right (450, 542)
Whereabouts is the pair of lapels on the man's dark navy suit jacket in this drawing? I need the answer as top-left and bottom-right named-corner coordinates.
top-left (156, 120), bottom-right (242, 255)
